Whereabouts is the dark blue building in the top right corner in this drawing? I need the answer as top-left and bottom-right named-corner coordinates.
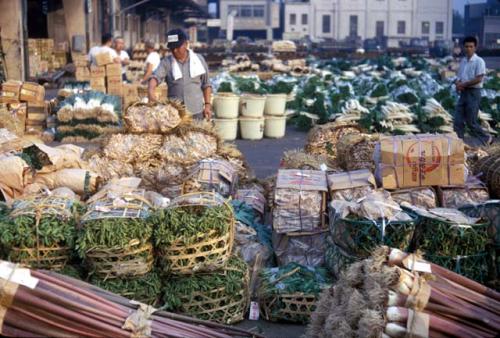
top-left (464, 0), bottom-right (500, 48)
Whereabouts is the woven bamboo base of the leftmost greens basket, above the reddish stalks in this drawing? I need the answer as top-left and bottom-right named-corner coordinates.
top-left (10, 245), bottom-right (71, 271)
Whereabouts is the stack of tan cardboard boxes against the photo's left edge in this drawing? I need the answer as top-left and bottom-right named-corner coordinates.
top-left (0, 80), bottom-right (48, 136)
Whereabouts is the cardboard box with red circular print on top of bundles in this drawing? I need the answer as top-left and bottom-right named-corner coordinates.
top-left (377, 134), bottom-right (465, 189)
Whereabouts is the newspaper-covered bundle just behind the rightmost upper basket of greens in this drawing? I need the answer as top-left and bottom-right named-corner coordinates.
top-left (182, 159), bottom-right (238, 198)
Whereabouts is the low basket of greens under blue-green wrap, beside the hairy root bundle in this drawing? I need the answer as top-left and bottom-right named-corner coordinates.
top-left (258, 263), bottom-right (331, 323)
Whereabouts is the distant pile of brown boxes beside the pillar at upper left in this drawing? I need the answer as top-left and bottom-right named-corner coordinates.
top-left (28, 39), bottom-right (67, 77)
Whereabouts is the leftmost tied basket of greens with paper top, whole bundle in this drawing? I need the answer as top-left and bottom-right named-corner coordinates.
top-left (0, 194), bottom-right (79, 270)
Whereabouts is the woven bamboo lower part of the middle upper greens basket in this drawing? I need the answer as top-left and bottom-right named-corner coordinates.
top-left (87, 240), bottom-right (154, 278)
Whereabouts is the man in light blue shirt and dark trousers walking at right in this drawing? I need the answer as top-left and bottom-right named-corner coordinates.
top-left (453, 36), bottom-right (493, 144)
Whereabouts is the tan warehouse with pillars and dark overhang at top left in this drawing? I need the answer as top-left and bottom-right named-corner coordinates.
top-left (0, 0), bottom-right (207, 79)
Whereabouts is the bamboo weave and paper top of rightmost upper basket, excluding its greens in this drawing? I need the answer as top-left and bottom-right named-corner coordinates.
top-left (157, 192), bottom-right (235, 275)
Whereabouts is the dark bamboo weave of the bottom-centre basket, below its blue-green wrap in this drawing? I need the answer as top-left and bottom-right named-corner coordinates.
top-left (260, 292), bottom-right (318, 324)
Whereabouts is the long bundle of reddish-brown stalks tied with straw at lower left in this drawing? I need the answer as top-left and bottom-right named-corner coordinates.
top-left (0, 261), bottom-right (259, 338)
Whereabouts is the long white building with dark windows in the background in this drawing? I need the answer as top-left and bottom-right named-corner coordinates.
top-left (284, 0), bottom-right (453, 45)
